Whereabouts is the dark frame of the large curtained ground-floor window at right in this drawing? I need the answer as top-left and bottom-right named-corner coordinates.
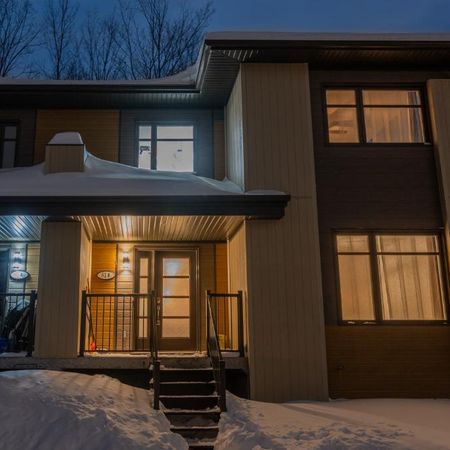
top-left (332, 228), bottom-right (450, 326)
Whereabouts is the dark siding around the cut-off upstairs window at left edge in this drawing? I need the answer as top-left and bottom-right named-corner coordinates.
top-left (0, 109), bottom-right (36, 166)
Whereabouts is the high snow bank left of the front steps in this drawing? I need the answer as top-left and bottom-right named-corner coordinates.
top-left (0, 370), bottom-right (188, 450)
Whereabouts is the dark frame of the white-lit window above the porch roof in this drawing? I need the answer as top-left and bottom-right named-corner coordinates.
top-left (134, 120), bottom-right (197, 175)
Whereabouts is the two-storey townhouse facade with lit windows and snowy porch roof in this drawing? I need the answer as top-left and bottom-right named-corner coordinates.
top-left (0, 33), bottom-right (450, 401)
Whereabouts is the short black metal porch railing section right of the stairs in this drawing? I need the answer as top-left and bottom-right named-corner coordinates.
top-left (206, 291), bottom-right (244, 356)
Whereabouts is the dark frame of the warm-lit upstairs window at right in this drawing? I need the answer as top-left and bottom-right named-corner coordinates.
top-left (321, 83), bottom-right (433, 148)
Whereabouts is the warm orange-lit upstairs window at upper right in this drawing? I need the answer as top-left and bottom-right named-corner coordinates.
top-left (326, 88), bottom-right (426, 144)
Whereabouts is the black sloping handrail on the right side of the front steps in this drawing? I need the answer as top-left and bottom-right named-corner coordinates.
top-left (206, 291), bottom-right (227, 411)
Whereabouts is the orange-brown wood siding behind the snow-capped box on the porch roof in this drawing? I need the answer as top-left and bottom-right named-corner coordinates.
top-left (34, 109), bottom-right (119, 164)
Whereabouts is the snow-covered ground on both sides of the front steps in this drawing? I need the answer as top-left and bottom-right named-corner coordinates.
top-left (0, 370), bottom-right (450, 450)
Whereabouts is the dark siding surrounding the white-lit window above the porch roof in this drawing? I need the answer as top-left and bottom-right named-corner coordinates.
top-left (120, 109), bottom-right (214, 178)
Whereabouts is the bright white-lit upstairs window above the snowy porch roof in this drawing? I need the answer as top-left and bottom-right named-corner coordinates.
top-left (138, 124), bottom-right (194, 172)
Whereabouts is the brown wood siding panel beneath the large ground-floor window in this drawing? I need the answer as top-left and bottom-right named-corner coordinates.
top-left (326, 326), bottom-right (450, 398)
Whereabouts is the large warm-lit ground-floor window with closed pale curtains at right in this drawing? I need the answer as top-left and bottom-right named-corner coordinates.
top-left (336, 233), bottom-right (447, 323)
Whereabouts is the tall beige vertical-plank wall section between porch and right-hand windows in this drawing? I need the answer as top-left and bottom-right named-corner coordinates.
top-left (226, 64), bottom-right (328, 401)
